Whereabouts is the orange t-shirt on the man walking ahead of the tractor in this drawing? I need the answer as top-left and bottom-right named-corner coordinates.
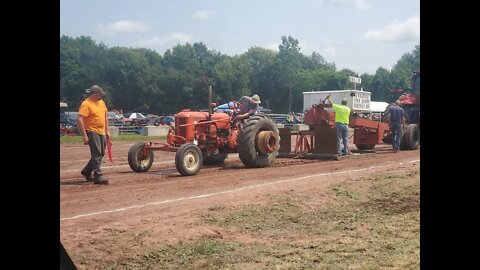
top-left (78, 98), bottom-right (108, 135)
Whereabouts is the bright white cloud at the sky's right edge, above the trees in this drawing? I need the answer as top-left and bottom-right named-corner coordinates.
top-left (363, 16), bottom-right (420, 43)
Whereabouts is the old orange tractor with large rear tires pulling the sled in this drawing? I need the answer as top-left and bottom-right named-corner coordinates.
top-left (128, 93), bottom-right (280, 176)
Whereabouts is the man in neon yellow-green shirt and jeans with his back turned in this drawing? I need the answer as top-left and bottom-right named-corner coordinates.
top-left (323, 94), bottom-right (350, 156)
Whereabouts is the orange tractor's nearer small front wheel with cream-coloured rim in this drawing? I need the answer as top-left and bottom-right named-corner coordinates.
top-left (175, 143), bottom-right (203, 176)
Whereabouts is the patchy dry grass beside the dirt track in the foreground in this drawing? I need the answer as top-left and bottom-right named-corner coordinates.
top-left (106, 170), bottom-right (420, 270)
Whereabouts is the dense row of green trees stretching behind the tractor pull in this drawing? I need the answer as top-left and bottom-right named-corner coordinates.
top-left (60, 35), bottom-right (420, 115)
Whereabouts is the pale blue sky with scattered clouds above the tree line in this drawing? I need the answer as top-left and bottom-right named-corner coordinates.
top-left (60, 0), bottom-right (420, 75)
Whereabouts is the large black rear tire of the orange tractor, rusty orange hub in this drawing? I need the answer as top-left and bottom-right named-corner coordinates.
top-left (237, 113), bottom-right (280, 168)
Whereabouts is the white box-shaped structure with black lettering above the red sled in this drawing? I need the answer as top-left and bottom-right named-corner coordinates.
top-left (303, 90), bottom-right (371, 113)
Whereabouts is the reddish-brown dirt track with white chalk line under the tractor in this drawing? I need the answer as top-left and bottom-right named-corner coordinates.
top-left (60, 138), bottom-right (420, 269)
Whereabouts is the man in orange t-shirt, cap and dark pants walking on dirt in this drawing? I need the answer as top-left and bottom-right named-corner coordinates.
top-left (77, 85), bottom-right (110, 184)
